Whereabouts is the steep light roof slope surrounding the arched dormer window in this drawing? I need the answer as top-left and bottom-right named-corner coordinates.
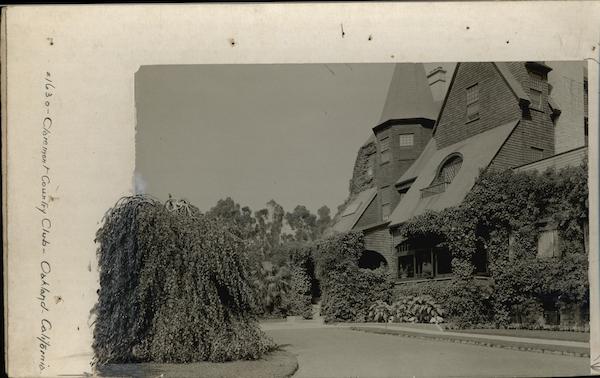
top-left (390, 120), bottom-right (519, 226)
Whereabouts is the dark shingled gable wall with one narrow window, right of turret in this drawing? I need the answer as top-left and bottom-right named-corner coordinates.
top-left (434, 63), bottom-right (521, 149)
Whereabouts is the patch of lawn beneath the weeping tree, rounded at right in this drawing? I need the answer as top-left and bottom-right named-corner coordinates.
top-left (98, 350), bottom-right (298, 378)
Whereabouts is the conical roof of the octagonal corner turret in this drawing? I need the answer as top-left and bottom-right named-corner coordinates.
top-left (379, 63), bottom-right (438, 124)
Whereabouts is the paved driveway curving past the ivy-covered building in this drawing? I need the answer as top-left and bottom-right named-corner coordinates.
top-left (267, 327), bottom-right (589, 378)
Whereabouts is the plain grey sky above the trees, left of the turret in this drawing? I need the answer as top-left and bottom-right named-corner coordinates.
top-left (135, 64), bottom-right (452, 215)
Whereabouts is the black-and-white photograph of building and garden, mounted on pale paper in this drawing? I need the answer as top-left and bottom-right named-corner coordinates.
top-left (90, 61), bottom-right (590, 378)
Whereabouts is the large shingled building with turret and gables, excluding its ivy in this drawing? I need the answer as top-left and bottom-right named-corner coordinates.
top-left (333, 62), bottom-right (587, 282)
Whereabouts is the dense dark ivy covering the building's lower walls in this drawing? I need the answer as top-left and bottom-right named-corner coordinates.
top-left (397, 163), bottom-right (589, 326)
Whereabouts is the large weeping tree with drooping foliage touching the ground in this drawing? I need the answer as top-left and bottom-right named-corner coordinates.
top-left (93, 195), bottom-right (274, 364)
